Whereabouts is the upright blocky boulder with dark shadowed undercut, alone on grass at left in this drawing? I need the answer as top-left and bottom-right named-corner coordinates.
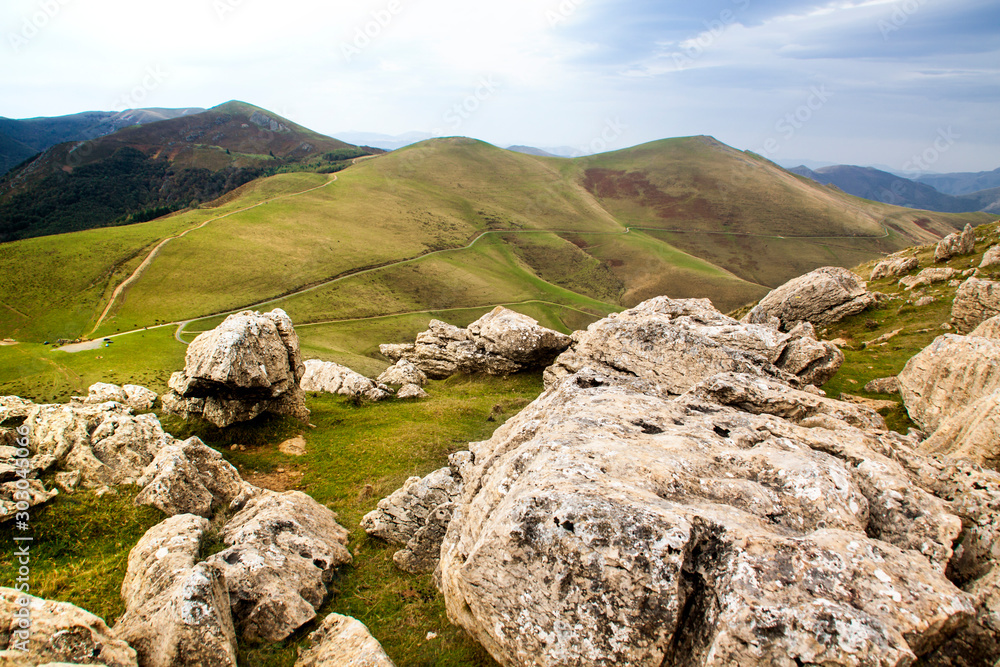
top-left (162, 309), bottom-right (309, 427)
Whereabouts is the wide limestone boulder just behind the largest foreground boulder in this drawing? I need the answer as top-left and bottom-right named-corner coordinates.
top-left (545, 297), bottom-right (844, 395)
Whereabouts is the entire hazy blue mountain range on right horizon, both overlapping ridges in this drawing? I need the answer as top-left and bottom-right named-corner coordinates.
top-left (789, 165), bottom-right (1000, 213)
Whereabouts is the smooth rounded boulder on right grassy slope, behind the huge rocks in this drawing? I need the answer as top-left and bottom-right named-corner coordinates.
top-left (744, 266), bottom-right (876, 331)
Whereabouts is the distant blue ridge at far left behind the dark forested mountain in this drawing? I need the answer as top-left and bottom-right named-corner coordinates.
top-left (0, 108), bottom-right (204, 176)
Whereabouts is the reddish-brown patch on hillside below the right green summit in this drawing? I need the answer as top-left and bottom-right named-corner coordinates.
top-left (583, 169), bottom-right (717, 220)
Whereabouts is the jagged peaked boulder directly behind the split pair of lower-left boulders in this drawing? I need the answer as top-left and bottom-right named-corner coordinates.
top-left (135, 438), bottom-right (248, 518)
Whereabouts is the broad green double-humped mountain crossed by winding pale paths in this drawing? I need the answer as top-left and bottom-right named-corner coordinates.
top-left (0, 137), bottom-right (992, 348)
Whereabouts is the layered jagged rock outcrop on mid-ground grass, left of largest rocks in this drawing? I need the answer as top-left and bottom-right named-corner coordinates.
top-left (379, 306), bottom-right (571, 380)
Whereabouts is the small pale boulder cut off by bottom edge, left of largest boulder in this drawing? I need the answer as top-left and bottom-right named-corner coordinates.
top-left (295, 614), bottom-right (394, 667)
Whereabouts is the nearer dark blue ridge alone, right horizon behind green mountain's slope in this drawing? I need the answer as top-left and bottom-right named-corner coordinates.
top-left (790, 165), bottom-right (986, 213)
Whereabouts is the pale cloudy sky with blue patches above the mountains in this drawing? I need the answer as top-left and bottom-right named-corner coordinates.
top-left (0, 0), bottom-right (1000, 173)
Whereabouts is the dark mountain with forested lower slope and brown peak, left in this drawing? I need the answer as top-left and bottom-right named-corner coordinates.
top-left (0, 102), bottom-right (375, 241)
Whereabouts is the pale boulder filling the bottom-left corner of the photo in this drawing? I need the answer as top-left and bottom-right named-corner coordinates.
top-left (0, 588), bottom-right (138, 667)
